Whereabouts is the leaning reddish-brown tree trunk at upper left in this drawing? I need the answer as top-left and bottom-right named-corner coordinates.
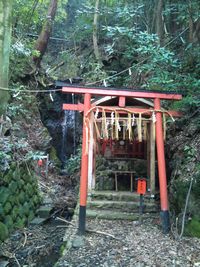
top-left (33, 0), bottom-right (58, 67)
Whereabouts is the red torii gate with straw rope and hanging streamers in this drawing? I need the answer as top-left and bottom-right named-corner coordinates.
top-left (62, 86), bottom-right (182, 234)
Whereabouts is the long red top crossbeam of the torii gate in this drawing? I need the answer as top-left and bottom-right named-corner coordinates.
top-left (62, 87), bottom-right (182, 100)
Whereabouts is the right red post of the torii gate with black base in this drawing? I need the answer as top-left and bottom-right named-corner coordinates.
top-left (154, 98), bottom-right (170, 234)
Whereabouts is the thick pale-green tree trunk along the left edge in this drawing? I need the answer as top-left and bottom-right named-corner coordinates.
top-left (0, 0), bottom-right (12, 115)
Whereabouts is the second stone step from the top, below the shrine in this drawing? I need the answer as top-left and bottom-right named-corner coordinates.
top-left (87, 200), bottom-right (158, 212)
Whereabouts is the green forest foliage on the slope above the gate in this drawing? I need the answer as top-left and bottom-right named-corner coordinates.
top-left (11, 0), bottom-right (200, 94)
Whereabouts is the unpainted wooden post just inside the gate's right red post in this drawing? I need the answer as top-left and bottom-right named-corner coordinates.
top-left (149, 122), bottom-right (156, 195)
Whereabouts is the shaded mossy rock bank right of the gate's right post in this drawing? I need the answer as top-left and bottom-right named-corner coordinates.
top-left (167, 112), bottom-right (200, 236)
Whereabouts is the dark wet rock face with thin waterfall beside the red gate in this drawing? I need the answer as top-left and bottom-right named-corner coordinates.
top-left (39, 92), bottom-right (82, 165)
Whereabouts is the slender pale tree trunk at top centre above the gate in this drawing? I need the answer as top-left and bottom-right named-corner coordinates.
top-left (93, 0), bottom-right (100, 63)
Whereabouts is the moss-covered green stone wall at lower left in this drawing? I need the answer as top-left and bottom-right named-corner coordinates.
top-left (0, 164), bottom-right (41, 242)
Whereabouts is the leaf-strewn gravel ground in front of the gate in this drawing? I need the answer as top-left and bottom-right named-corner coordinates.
top-left (56, 219), bottom-right (200, 267)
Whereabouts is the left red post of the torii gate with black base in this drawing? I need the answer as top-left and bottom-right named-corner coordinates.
top-left (79, 93), bottom-right (91, 234)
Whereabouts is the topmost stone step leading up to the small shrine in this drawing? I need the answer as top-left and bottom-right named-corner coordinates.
top-left (88, 191), bottom-right (155, 203)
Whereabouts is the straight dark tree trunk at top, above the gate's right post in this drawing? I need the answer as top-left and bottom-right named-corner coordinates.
top-left (156, 0), bottom-right (164, 46)
